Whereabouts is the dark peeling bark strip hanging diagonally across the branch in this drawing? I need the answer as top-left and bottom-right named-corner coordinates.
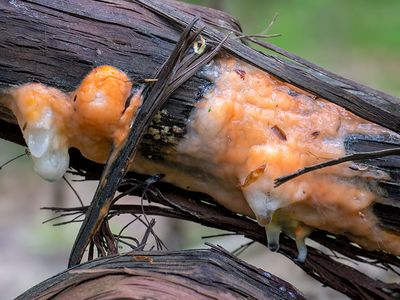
top-left (68, 18), bottom-right (226, 267)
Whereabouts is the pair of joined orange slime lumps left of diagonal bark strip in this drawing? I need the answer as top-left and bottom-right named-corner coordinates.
top-left (2, 66), bottom-right (141, 181)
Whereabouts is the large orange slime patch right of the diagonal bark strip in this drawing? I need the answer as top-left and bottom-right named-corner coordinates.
top-left (174, 58), bottom-right (400, 260)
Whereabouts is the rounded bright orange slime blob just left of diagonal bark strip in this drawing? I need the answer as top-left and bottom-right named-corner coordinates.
top-left (70, 66), bottom-right (141, 162)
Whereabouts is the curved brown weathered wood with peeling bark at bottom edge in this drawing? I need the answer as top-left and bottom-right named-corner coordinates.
top-left (17, 247), bottom-right (305, 300)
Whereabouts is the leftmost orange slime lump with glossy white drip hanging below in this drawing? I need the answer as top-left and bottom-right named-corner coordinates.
top-left (7, 83), bottom-right (72, 181)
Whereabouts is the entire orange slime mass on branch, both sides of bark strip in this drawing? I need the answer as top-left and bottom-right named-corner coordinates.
top-left (5, 57), bottom-right (400, 261)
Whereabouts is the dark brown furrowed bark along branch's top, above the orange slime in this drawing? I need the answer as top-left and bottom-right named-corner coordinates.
top-left (0, 0), bottom-right (400, 132)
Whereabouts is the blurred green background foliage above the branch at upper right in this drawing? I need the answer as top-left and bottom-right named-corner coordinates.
top-left (186, 0), bottom-right (400, 96)
